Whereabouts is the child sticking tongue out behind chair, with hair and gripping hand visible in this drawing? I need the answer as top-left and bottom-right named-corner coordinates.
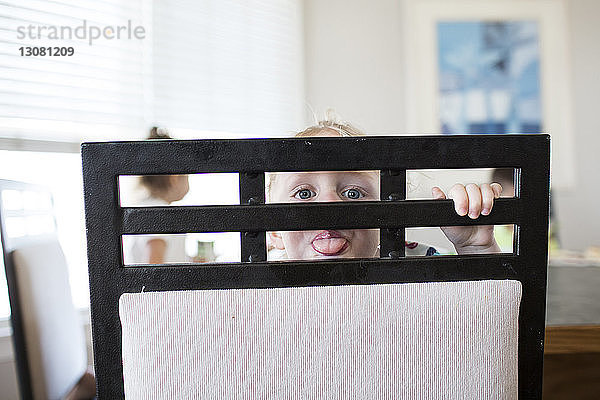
top-left (267, 120), bottom-right (502, 260)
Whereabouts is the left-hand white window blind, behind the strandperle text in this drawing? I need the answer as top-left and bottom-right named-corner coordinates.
top-left (0, 0), bottom-right (151, 142)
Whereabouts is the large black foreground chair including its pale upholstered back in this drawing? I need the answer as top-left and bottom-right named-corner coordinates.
top-left (82, 135), bottom-right (549, 399)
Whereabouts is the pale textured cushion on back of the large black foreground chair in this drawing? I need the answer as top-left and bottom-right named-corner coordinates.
top-left (120, 280), bottom-right (521, 399)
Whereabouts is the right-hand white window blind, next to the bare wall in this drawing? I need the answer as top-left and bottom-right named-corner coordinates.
top-left (153, 0), bottom-right (304, 137)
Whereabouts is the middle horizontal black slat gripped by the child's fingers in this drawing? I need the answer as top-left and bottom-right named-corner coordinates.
top-left (122, 199), bottom-right (521, 234)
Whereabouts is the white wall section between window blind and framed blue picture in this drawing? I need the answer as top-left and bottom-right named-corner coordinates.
top-left (304, 0), bottom-right (404, 134)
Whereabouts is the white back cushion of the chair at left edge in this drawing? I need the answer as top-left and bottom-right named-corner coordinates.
top-left (11, 240), bottom-right (87, 399)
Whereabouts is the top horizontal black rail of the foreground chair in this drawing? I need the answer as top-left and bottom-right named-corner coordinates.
top-left (82, 134), bottom-right (549, 175)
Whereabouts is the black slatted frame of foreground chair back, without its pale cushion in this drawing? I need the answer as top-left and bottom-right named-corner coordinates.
top-left (82, 134), bottom-right (550, 399)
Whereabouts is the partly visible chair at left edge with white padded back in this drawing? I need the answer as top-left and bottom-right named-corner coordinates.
top-left (0, 180), bottom-right (93, 399)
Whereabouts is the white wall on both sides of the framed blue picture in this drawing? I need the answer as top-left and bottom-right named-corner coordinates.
top-left (304, 0), bottom-right (600, 250)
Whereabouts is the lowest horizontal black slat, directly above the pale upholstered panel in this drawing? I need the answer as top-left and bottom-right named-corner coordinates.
top-left (114, 254), bottom-right (527, 292)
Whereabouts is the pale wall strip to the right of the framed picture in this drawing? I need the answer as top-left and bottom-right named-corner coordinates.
top-left (554, 0), bottom-right (600, 250)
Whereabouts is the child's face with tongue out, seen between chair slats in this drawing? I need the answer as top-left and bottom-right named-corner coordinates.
top-left (270, 171), bottom-right (379, 260)
